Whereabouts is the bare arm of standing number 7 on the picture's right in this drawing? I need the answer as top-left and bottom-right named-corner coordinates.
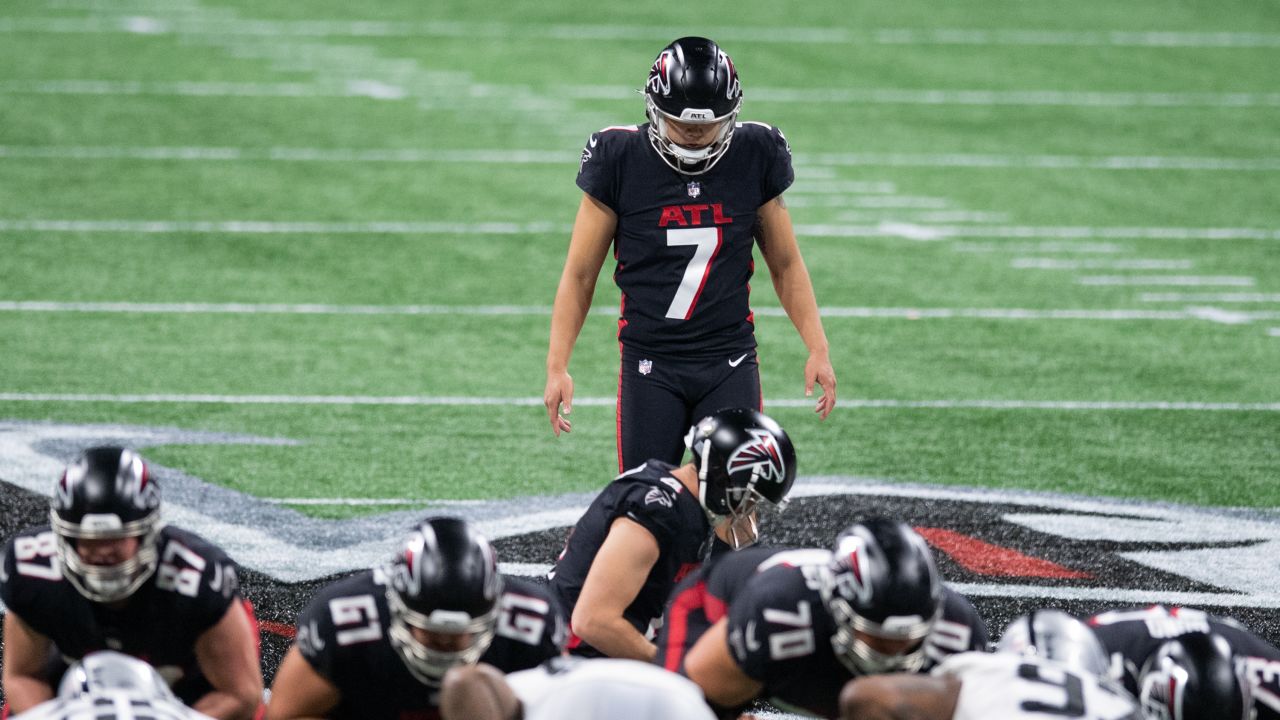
top-left (756, 195), bottom-right (836, 419)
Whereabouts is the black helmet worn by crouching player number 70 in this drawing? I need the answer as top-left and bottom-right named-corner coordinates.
top-left (819, 518), bottom-right (942, 675)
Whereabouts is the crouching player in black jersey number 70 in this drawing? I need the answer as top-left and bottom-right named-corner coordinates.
top-left (681, 518), bottom-right (988, 717)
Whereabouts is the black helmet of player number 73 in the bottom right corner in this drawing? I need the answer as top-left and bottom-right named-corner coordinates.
top-left (1138, 633), bottom-right (1256, 720)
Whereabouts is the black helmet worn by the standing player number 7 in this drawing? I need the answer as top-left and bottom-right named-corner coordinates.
top-left (644, 37), bottom-right (742, 176)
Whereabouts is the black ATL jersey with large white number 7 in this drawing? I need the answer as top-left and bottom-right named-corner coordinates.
top-left (577, 123), bottom-right (795, 356)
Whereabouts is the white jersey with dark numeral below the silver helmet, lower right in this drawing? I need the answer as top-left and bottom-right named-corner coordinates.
top-left (933, 652), bottom-right (1142, 720)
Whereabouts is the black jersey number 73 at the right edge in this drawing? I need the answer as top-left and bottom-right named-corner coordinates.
top-left (1089, 605), bottom-right (1280, 720)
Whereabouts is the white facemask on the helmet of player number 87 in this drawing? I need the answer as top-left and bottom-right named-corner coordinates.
top-left (50, 511), bottom-right (161, 602)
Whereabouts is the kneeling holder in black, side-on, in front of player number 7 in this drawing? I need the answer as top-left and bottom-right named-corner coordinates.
top-left (552, 409), bottom-right (796, 661)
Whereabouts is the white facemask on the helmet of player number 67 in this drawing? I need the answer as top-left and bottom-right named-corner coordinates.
top-left (387, 589), bottom-right (498, 687)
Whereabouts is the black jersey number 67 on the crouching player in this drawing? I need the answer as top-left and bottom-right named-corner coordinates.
top-left (297, 570), bottom-right (564, 720)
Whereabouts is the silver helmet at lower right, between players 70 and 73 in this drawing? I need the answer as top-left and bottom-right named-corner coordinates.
top-left (996, 610), bottom-right (1111, 678)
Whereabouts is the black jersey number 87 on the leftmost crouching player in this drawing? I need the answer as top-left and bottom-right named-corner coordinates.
top-left (0, 525), bottom-right (242, 703)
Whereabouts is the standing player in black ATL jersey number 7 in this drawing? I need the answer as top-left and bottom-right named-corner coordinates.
top-left (543, 37), bottom-right (836, 470)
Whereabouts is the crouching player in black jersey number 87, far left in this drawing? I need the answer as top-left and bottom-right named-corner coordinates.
top-left (0, 447), bottom-right (262, 717)
